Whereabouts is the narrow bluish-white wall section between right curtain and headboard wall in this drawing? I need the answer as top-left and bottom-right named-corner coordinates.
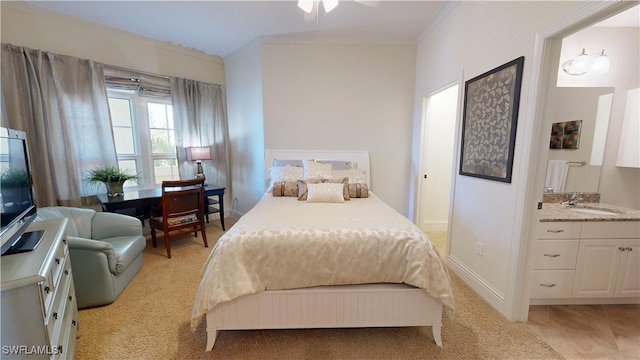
top-left (224, 42), bottom-right (265, 216)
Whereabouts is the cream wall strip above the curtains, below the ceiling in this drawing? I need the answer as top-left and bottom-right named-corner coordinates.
top-left (0, 1), bottom-right (225, 84)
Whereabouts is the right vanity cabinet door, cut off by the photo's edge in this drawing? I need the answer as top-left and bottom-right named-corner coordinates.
top-left (616, 239), bottom-right (640, 297)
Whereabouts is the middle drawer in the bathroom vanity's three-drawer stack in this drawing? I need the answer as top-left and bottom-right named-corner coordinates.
top-left (533, 240), bottom-right (580, 270)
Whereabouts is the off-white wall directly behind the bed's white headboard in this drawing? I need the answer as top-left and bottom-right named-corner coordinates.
top-left (262, 42), bottom-right (416, 215)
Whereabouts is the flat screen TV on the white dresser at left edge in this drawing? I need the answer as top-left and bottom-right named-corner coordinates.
top-left (0, 127), bottom-right (43, 256)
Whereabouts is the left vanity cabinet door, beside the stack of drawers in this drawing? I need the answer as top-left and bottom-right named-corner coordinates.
top-left (573, 239), bottom-right (624, 298)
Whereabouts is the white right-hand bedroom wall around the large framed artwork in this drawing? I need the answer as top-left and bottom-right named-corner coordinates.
top-left (412, 1), bottom-right (584, 315)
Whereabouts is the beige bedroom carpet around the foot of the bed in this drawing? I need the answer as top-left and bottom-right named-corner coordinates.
top-left (76, 225), bottom-right (562, 360)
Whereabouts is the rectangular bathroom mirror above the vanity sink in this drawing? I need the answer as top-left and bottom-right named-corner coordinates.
top-left (545, 87), bottom-right (614, 193)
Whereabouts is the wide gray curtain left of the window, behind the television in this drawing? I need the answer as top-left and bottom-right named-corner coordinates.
top-left (1, 44), bottom-right (117, 206)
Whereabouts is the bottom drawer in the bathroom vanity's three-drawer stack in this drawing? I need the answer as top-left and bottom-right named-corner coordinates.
top-left (531, 270), bottom-right (575, 299)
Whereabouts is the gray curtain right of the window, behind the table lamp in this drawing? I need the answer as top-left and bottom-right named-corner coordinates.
top-left (171, 77), bottom-right (231, 192)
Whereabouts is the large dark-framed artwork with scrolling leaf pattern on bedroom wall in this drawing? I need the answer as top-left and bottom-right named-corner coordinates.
top-left (460, 56), bottom-right (524, 183)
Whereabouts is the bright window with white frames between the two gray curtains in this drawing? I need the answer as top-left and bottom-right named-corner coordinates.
top-left (108, 89), bottom-right (180, 187)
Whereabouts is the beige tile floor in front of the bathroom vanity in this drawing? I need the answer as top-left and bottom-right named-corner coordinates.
top-left (527, 304), bottom-right (640, 360)
